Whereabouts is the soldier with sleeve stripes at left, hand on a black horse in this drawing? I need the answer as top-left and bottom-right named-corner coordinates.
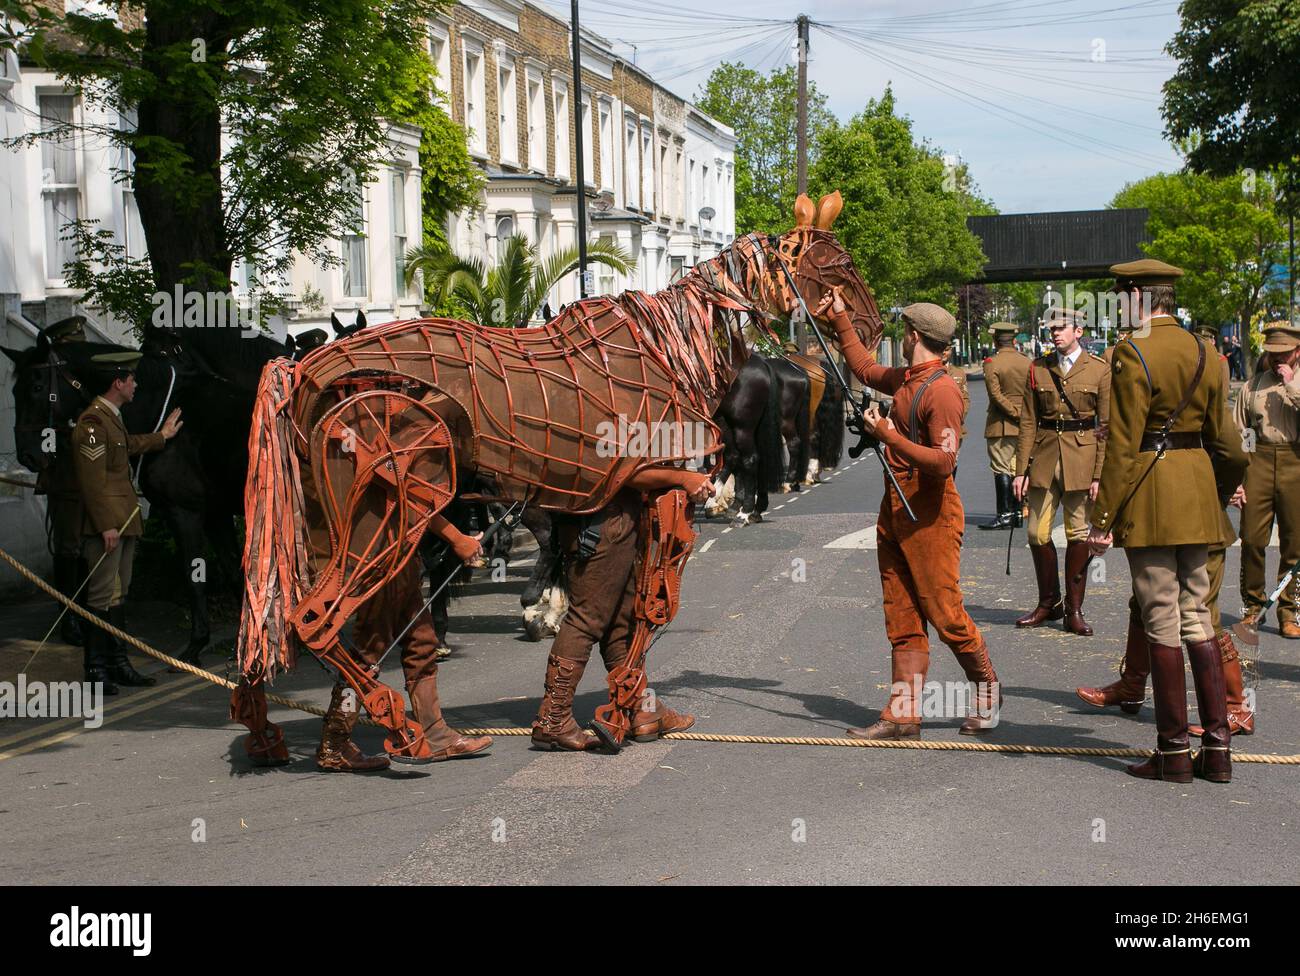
top-left (72, 350), bottom-right (181, 695)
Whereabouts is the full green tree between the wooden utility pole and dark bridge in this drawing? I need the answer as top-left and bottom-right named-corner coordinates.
top-left (810, 90), bottom-right (989, 311)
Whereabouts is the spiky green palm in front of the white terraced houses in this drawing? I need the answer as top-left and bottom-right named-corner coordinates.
top-left (406, 234), bottom-right (637, 327)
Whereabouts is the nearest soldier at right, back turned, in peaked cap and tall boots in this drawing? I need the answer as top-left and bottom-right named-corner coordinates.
top-left (1088, 259), bottom-right (1245, 782)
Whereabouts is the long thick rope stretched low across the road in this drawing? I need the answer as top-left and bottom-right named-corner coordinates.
top-left (0, 548), bottom-right (1300, 765)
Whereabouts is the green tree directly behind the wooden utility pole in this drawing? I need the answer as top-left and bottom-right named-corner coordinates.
top-left (696, 61), bottom-right (835, 234)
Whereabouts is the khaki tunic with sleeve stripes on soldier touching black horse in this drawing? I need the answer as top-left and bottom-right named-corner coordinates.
top-left (73, 396), bottom-right (166, 535)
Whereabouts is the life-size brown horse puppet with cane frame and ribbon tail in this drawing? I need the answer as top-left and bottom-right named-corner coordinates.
top-left (231, 194), bottom-right (881, 763)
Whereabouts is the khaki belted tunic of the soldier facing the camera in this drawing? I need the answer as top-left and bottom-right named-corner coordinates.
top-left (1015, 350), bottom-right (1110, 491)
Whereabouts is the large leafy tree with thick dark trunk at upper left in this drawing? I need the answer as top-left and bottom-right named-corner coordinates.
top-left (0, 0), bottom-right (477, 347)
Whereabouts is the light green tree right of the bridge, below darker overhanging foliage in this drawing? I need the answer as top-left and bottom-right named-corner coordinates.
top-left (1110, 173), bottom-right (1287, 326)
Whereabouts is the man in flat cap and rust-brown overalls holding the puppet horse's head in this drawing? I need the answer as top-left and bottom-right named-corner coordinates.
top-left (815, 291), bottom-right (1001, 738)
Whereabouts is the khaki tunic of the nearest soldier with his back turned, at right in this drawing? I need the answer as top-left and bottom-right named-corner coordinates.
top-left (1092, 316), bottom-right (1247, 548)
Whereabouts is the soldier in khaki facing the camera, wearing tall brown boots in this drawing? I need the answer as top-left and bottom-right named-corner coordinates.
top-left (1013, 308), bottom-right (1110, 637)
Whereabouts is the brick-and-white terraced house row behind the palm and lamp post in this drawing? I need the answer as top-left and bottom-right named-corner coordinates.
top-left (429, 0), bottom-right (736, 307)
